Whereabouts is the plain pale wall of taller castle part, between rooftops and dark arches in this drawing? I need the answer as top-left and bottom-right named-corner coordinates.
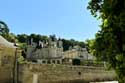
top-left (27, 46), bottom-right (63, 59)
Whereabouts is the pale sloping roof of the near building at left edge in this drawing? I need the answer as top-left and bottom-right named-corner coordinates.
top-left (0, 35), bottom-right (17, 48)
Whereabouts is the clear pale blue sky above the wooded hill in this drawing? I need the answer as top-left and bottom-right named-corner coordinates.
top-left (0, 0), bottom-right (100, 41)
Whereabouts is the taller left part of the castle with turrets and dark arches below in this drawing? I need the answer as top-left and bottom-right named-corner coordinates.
top-left (27, 39), bottom-right (63, 64)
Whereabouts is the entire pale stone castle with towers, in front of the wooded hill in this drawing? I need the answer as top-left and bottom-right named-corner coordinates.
top-left (26, 37), bottom-right (95, 64)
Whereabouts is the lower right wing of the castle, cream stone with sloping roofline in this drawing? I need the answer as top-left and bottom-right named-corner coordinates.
top-left (63, 46), bottom-right (95, 64)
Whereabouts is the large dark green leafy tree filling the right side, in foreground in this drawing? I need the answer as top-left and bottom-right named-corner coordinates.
top-left (87, 0), bottom-right (125, 83)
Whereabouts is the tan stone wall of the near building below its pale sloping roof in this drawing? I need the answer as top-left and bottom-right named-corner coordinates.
top-left (0, 47), bottom-right (15, 83)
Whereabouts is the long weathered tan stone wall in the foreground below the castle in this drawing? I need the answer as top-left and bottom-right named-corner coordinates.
top-left (19, 63), bottom-right (116, 83)
